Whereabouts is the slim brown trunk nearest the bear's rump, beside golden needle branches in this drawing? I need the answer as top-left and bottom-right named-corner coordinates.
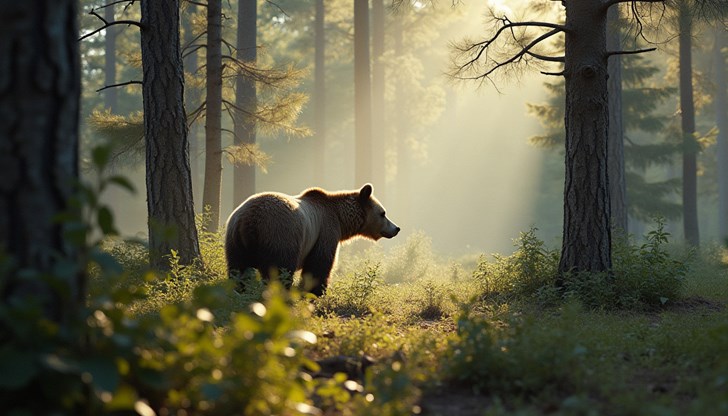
top-left (202, 0), bottom-right (222, 231)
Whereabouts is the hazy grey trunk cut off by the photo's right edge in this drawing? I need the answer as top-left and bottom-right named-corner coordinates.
top-left (713, 27), bottom-right (728, 241)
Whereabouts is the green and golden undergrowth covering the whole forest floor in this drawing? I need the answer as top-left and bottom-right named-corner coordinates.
top-left (0, 152), bottom-right (728, 416)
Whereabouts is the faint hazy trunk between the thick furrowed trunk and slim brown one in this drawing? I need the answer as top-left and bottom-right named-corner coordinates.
top-left (182, 3), bottom-right (202, 208)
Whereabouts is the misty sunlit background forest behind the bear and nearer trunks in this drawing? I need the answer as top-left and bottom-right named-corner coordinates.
top-left (82, 1), bottom-right (720, 255)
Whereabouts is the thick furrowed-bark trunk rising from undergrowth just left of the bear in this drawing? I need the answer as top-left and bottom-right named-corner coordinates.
top-left (141, 0), bottom-right (200, 270)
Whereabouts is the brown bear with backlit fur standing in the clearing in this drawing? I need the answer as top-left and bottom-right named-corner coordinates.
top-left (225, 184), bottom-right (400, 296)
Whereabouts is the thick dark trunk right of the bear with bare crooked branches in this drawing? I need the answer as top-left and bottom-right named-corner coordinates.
top-left (454, 0), bottom-right (664, 283)
